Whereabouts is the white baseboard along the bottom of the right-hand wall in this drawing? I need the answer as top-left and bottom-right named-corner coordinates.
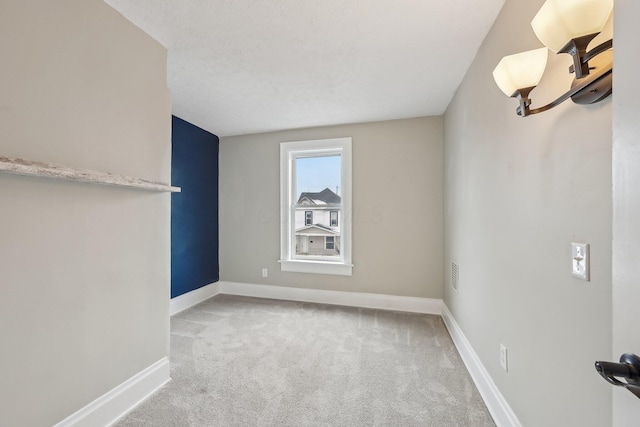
top-left (442, 303), bottom-right (522, 427)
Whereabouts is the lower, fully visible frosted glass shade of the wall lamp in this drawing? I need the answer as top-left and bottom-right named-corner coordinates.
top-left (493, 47), bottom-right (549, 96)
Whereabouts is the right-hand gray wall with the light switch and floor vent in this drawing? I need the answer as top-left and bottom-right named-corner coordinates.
top-left (444, 0), bottom-right (612, 426)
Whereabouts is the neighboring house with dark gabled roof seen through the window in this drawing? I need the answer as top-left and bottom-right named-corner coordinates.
top-left (295, 188), bottom-right (342, 256)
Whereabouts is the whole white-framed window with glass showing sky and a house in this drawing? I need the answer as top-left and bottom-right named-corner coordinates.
top-left (280, 138), bottom-right (353, 276)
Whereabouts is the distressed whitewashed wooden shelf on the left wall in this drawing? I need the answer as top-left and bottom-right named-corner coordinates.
top-left (0, 156), bottom-right (181, 193)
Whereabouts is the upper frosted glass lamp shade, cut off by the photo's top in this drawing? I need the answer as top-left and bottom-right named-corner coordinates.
top-left (531, 0), bottom-right (613, 53)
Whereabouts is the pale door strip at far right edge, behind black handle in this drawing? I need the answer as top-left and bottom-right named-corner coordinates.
top-left (611, 0), bottom-right (640, 427)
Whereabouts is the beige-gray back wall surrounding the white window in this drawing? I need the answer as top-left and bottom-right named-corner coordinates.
top-left (220, 117), bottom-right (443, 298)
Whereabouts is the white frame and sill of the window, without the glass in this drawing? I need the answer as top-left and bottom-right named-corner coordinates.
top-left (280, 138), bottom-right (353, 276)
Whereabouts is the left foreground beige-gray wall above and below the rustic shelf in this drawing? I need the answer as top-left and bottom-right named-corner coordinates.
top-left (0, 0), bottom-right (171, 426)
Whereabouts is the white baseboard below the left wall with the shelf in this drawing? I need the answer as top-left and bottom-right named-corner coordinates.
top-left (54, 357), bottom-right (171, 427)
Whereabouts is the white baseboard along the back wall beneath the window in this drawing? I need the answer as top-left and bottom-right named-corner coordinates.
top-left (218, 282), bottom-right (442, 315)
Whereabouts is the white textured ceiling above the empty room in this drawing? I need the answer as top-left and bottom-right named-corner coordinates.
top-left (105, 0), bottom-right (504, 136)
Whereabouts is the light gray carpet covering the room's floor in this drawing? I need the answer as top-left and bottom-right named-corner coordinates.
top-left (116, 295), bottom-right (494, 427)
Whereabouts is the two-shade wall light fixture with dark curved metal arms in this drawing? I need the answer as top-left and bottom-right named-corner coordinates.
top-left (493, 0), bottom-right (613, 117)
